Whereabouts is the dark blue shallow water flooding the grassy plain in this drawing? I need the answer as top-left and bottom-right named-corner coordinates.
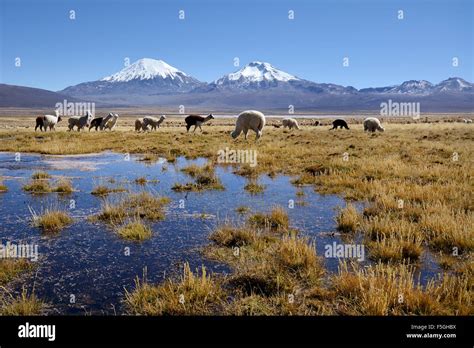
top-left (0, 153), bottom-right (436, 314)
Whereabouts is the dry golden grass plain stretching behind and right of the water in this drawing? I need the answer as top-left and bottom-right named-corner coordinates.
top-left (0, 119), bottom-right (474, 315)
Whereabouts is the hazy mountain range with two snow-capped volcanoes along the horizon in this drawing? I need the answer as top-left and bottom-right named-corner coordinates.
top-left (0, 58), bottom-right (474, 112)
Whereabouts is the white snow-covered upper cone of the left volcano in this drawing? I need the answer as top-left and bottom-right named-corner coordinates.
top-left (101, 58), bottom-right (186, 82)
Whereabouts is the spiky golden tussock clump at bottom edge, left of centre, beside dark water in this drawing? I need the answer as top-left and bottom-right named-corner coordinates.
top-left (125, 263), bottom-right (225, 315)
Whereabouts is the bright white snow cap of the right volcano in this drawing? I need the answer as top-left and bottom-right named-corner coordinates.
top-left (215, 61), bottom-right (299, 85)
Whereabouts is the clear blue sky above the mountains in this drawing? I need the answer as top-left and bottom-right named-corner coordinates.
top-left (0, 0), bottom-right (474, 90)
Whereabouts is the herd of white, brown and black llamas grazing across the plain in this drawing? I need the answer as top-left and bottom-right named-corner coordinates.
top-left (35, 110), bottom-right (472, 139)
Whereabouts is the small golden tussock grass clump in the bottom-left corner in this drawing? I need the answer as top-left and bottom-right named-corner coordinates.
top-left (0, 288), bottom-right (45, 316)
